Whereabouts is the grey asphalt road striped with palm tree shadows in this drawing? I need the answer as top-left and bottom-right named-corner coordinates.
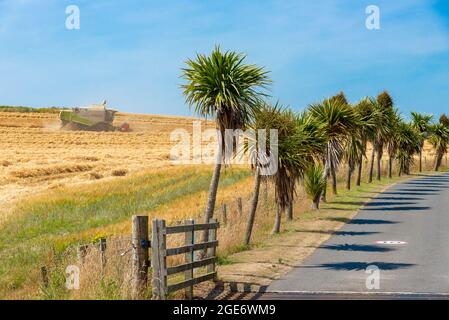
top-left (262, 174), bottom-right (449, 299)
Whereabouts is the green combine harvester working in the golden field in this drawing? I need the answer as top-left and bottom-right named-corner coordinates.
top-left (59, 100), bottom-right (131, 132)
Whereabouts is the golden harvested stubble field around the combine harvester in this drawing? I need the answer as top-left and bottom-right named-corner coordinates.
top-left (0, 112), bottom-right (213, 218)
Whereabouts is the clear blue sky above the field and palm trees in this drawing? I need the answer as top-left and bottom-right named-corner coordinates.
top-left (0, 0), bottom-right (449, 115)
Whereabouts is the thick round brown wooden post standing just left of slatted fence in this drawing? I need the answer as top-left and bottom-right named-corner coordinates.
top-left (131, 216), bottom-right (150, 299)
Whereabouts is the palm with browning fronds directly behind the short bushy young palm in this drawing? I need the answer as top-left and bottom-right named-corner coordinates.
top-left (309, 95), bottom-right (358, 200)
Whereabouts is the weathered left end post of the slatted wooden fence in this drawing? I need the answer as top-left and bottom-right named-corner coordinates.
top-left (151, 219), bottom-right (167, 300)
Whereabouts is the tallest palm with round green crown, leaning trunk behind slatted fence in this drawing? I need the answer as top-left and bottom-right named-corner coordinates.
top-left (182, 47), bottom-right (271, 245)
